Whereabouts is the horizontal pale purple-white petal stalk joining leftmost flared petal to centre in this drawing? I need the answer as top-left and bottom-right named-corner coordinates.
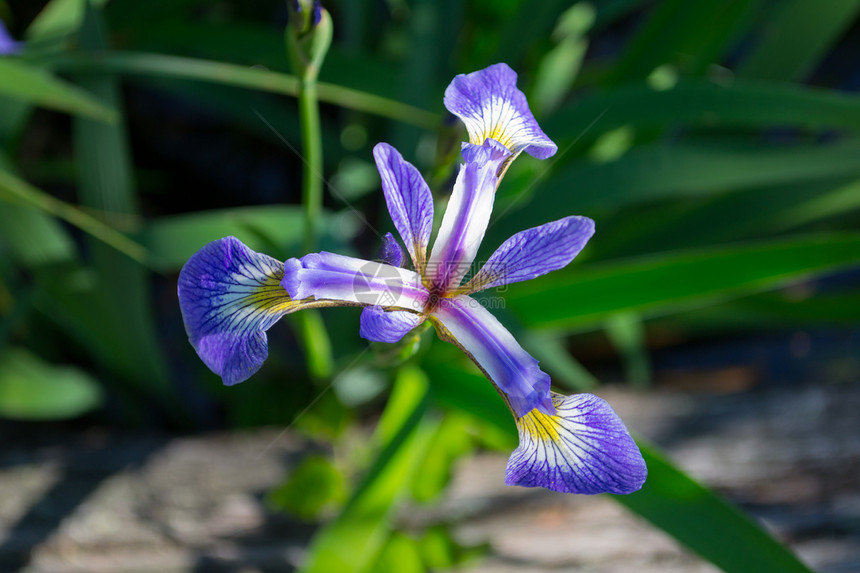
top-left (281, 251), bottom-right (428, 312)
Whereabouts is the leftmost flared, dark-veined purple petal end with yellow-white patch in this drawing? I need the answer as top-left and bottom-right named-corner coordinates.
top-left (177, 237), bottom-right (301, 385)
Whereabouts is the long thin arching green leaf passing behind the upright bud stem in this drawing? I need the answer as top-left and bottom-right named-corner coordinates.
top-left (49, 52), bottom-right (439, 128)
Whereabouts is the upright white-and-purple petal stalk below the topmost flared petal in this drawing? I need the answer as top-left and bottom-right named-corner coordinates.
top-left (425, 139), bottom-right (510, 293)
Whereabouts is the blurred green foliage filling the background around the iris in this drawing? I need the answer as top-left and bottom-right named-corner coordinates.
top-left (0, 0), bottom-right (860, 572)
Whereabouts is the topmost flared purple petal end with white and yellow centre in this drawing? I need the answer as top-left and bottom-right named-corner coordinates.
top-left (445, 64), bottom-right (558, 159)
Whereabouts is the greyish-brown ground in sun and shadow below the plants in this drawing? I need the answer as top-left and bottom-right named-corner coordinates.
top-left (0, 373), bottom-right (860, 573)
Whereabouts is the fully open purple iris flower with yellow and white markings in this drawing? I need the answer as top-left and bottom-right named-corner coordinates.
top-left (178, 64), bottom-right (647, 494)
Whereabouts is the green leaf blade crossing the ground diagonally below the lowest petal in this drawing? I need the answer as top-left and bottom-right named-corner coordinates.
top-left (612, 441), bottom-right (810, 573)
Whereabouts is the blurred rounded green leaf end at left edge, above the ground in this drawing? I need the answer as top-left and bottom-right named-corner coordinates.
top-left (0, 348), bottom-right (102, 420)
